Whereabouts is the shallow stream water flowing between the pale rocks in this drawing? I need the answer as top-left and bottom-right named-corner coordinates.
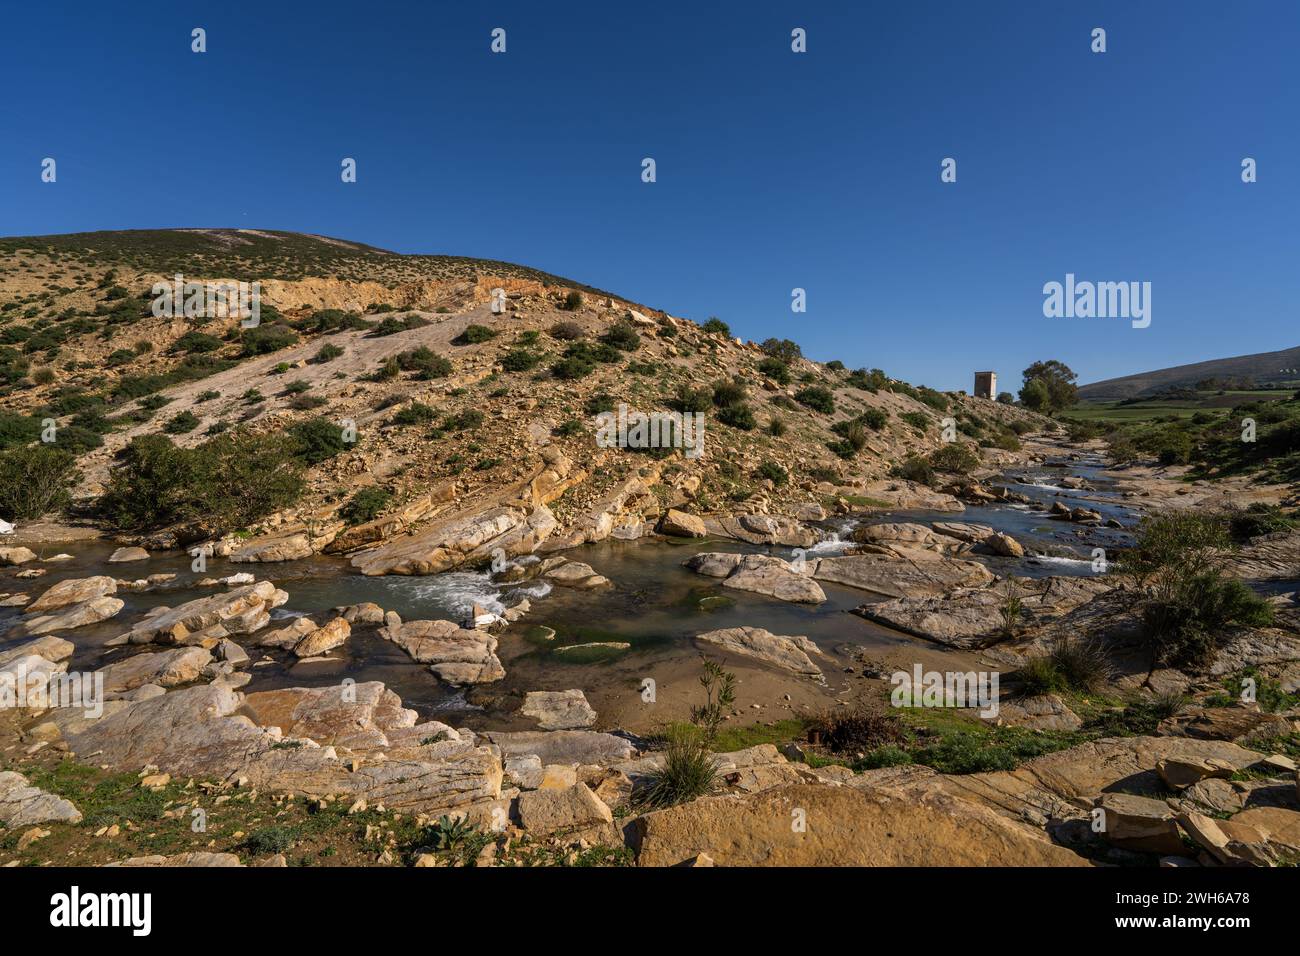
top-left (0, 462), bottom-right (1136, 723)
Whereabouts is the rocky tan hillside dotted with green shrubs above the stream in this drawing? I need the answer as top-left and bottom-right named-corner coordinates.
top-left (0, 230), bottom-right (1045, 546)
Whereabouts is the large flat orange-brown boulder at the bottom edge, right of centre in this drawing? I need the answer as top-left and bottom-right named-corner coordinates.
top-left (631, 784), bottom-right (1087, 866)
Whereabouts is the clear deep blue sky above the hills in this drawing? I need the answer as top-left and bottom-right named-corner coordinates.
top-left (0, 0), bottom-right (1300, 389)
